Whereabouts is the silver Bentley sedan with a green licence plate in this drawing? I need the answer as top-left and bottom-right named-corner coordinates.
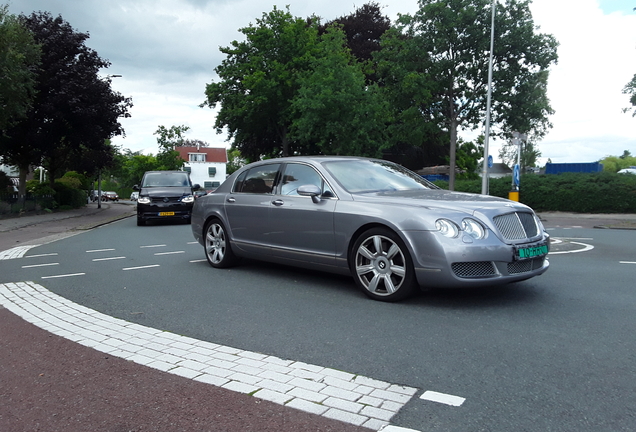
top-left (192, 156), bottom-right (550, 301)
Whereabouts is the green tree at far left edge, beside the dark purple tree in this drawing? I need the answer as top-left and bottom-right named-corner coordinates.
top-left (0, 5), bottom-right (41, 130)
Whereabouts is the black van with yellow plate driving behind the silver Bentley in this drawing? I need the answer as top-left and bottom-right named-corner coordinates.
top-left (133, 171), bottom-right (200, 226)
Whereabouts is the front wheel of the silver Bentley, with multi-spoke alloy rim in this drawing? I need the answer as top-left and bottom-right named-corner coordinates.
top-left (351, 228), bottom-right (417, 302)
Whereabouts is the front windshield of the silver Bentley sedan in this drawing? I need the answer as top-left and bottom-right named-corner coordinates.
top-left (324, 160), bottom-right (439, 193)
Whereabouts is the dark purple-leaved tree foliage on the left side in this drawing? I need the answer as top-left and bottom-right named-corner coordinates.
top-left (0, 12), bottom-right (132, 192)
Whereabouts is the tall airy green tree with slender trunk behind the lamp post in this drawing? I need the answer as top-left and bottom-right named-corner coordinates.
top-left (390, 0), bottom-right (557, 189)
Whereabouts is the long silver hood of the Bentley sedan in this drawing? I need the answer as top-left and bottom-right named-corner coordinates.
top-left (353, 189), bottom-right (530, 215)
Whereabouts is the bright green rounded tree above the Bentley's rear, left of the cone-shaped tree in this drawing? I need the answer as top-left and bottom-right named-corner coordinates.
top-left (203, 7), bottom-right (318, 161)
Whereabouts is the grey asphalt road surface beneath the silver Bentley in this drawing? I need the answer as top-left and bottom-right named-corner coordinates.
top-left (0, 218), bottom-right (636, 432)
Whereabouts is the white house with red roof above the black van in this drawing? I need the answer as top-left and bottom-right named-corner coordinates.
top-left (175, 146), bottom-right (227, 192)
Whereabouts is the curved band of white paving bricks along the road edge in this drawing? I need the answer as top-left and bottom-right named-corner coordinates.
top-left (0, 282), bottom-right (417, 432)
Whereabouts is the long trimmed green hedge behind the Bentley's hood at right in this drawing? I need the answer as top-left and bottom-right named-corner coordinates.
top-left (435, 172), bottom-right (636, 213)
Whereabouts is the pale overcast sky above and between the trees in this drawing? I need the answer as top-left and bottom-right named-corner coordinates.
top-left (6, 0), bottom-right (636, 162)
